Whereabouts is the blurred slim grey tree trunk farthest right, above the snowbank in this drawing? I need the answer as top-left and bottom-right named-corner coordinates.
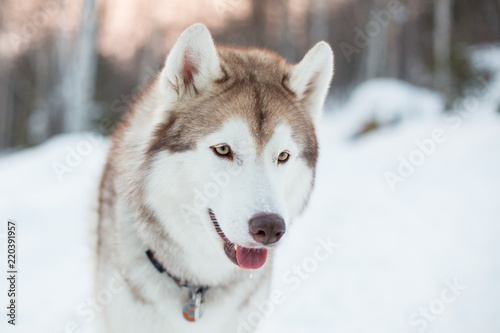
top-left (433, 0), bottom-right (452, 90)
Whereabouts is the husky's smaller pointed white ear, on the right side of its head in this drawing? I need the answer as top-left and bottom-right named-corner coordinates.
top-left (289, 42), bottom-right (333, 122)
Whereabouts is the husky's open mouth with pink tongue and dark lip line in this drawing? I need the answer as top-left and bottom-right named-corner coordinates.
top-left (208, 208), bottom-right (267, 269)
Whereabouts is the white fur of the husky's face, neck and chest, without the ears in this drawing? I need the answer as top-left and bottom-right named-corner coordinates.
top-left (100, 119), bottom-right (312, 333)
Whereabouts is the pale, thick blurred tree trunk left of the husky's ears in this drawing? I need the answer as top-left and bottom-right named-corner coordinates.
top-left (63, 0), bottom-right (97, 131)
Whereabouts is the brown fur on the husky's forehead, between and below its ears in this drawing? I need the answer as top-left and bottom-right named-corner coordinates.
top-left (149, 46), bottom-right (318, 167)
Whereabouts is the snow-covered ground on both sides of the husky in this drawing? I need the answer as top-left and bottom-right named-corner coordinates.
top-left (0, 46), bottom-right (500, 333)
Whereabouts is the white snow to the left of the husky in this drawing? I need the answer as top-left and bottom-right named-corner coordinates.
top-left (0, 134), bottom-right (107, 333)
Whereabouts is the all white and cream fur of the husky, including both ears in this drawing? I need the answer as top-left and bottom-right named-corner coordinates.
top-left (96, 24), bottom-right (333, 333)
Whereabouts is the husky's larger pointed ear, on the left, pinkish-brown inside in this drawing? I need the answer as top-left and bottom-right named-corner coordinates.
top-left (160, 23), bottom-right (223, 103)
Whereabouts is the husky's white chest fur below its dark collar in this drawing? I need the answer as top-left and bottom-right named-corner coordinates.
top-left (103, 268), bottom-right (269, 333)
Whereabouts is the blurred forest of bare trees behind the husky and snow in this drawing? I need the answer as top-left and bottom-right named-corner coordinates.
top-left (0, 0), bottom-right (500, 151)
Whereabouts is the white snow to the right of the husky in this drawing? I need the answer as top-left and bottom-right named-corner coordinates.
top-left (259, 109), bottom-right (500, 333)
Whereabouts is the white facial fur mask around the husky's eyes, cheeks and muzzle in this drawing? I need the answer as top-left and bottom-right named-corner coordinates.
top-left (146, 119), bottom-right (312, 270)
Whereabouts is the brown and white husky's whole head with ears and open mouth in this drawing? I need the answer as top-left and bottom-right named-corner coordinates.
top-left (143, 24), bottom-right (333, 268)
